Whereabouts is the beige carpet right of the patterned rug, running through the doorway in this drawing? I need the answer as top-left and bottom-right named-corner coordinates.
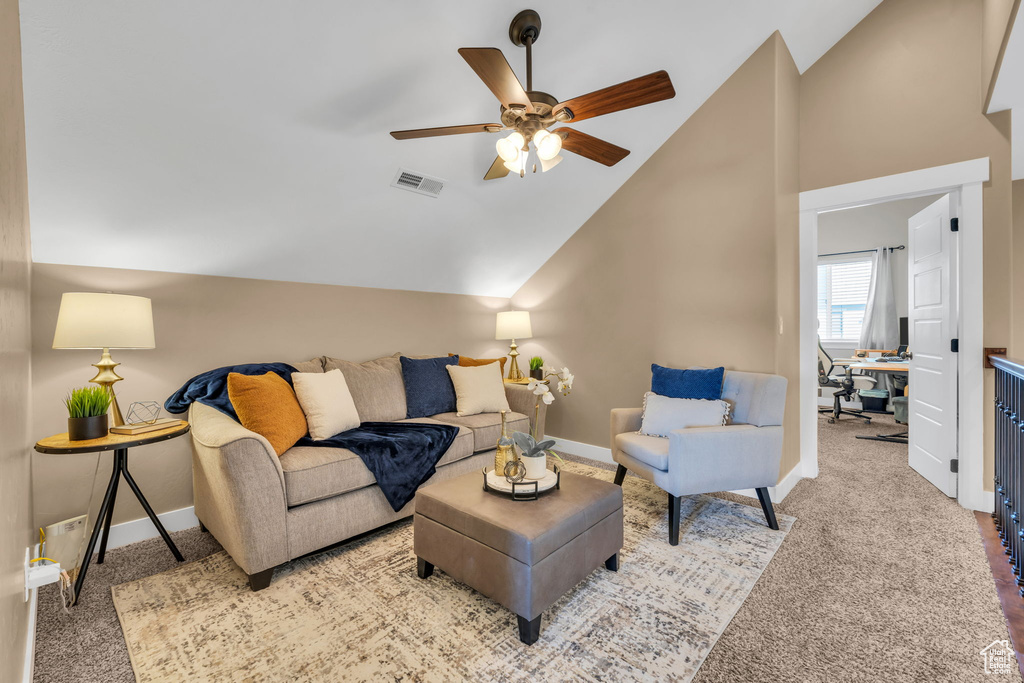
top-left (694, 417), bottom-right (1020, 683)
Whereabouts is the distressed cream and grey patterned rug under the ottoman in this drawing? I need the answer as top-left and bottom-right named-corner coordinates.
top-left (112, 462), bottom-right (795, 682)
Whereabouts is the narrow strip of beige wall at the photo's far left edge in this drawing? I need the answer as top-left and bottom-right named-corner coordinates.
top-left (0, 0), bottom-right (32, 681)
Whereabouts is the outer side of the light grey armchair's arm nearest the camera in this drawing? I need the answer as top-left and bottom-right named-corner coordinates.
top-left (669, 425), bottom-right (782, 496)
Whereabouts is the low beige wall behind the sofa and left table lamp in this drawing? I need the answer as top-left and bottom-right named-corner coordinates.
top-left (32, 264), bottom-right (508, 524)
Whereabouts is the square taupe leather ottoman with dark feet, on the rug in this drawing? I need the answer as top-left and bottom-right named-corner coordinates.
top-left (413, 472), bottom-right (623, 645)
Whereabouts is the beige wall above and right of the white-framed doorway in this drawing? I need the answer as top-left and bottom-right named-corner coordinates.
top-left (800, 0), bottom-right (1024, 487)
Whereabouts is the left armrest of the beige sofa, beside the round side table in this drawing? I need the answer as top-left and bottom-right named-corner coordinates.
top-left (188, 403), bottom-right (290, 573)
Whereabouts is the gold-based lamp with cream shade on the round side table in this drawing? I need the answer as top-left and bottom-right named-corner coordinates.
top-left (53, 292), bottom-right (157, 427)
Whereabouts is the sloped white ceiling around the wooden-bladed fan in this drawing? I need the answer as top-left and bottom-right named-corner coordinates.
top-left (22, 0), bottom-right (880, 296)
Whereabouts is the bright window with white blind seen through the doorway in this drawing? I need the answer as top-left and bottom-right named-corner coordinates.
top-left (818, 256), bottom-right (872, 344)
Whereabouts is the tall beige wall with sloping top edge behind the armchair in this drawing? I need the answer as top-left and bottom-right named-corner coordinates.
top-left (513, 34), bottom-right (799, 481)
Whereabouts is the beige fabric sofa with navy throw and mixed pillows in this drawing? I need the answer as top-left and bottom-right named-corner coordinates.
top-left (188, 353), bottom-right (546, 591)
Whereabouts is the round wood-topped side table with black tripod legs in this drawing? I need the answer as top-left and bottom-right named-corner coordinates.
top-left (36, 422), bottom-right (188, 605)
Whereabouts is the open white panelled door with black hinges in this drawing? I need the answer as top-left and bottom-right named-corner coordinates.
top-left (907, 195), bottom-right (958, 497)
